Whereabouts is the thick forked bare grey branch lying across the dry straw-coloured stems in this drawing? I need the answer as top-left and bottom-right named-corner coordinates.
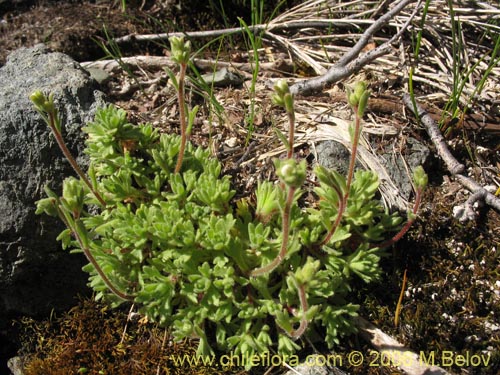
top-left (290, 0), bottom-right (421, 95)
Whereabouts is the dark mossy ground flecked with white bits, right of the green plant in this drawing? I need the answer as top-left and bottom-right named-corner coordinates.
top-left (358, 188), bottom-right (500, 374)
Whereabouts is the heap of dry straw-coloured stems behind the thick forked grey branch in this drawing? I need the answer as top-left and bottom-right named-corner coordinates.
top-left (268, 0), bottom-right (500, 113)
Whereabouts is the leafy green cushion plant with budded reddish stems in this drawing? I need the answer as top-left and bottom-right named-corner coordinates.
top-left (32, 73), bottom-right (426, 364)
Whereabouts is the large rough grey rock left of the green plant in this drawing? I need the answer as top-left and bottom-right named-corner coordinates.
top-left (0, 45), bottom-right (105, 321)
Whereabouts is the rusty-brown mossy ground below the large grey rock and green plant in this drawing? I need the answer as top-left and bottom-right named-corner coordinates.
top-left (19, 299), bottom-right (246, 375)
